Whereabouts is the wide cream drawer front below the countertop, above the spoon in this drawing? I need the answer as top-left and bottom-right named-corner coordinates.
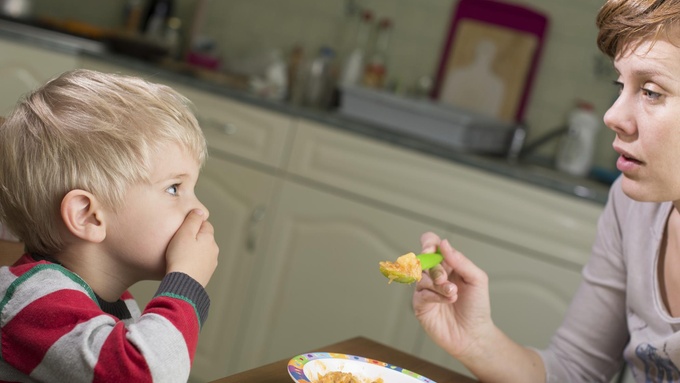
top-left (289, 121), bottom-right (603, 269)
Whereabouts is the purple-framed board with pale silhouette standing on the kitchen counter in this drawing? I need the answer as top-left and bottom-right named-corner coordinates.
top-left (432, 0), bottom-right (548, 122)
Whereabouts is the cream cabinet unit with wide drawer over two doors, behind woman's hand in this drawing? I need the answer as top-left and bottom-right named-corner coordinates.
top-left (268, 121), bottom-right (602, 373)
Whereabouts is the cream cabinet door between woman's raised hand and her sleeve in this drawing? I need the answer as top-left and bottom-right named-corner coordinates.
top-left (417, 228), bottom-right (581, 375)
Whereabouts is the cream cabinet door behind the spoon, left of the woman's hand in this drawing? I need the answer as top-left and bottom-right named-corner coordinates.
top-left (239, 182), bottom-right (452, 374)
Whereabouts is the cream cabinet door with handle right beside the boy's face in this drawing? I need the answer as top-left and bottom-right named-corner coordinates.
top-left (130, 156), bottom-right (278, 382)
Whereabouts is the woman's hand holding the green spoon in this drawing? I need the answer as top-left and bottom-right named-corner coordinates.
top-left (413, 233), bottom-right (496, 359)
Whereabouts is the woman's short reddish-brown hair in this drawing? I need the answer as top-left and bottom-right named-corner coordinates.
top-left (596, 0), bottom-right (680, 59)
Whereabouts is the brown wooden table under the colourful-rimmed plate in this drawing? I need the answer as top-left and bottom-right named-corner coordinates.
top-left (212, 337), bottom-right (477, 383)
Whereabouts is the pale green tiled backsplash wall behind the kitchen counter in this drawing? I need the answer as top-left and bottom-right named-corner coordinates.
top-left (30, 0), bottom-right (616, 169)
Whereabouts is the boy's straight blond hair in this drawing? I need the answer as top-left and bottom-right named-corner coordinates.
top-left (0, 70), bottom-right (207, 255)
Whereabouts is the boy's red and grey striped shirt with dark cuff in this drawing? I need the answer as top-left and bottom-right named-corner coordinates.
top-left (0, 254), bottom-right (210, 382)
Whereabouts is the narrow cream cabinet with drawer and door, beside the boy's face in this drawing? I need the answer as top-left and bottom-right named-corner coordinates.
top-left (163, 84), bottom-right (292, 382)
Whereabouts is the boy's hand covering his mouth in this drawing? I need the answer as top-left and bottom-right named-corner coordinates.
top-left (165, 210), bottom-right (220, 287)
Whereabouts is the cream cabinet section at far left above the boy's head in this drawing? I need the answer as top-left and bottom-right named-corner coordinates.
top-left (0, 40), bottom-right (77, 116)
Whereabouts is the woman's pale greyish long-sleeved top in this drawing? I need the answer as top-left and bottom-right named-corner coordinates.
top-left (540, 179), bottom-right (680, 382)
